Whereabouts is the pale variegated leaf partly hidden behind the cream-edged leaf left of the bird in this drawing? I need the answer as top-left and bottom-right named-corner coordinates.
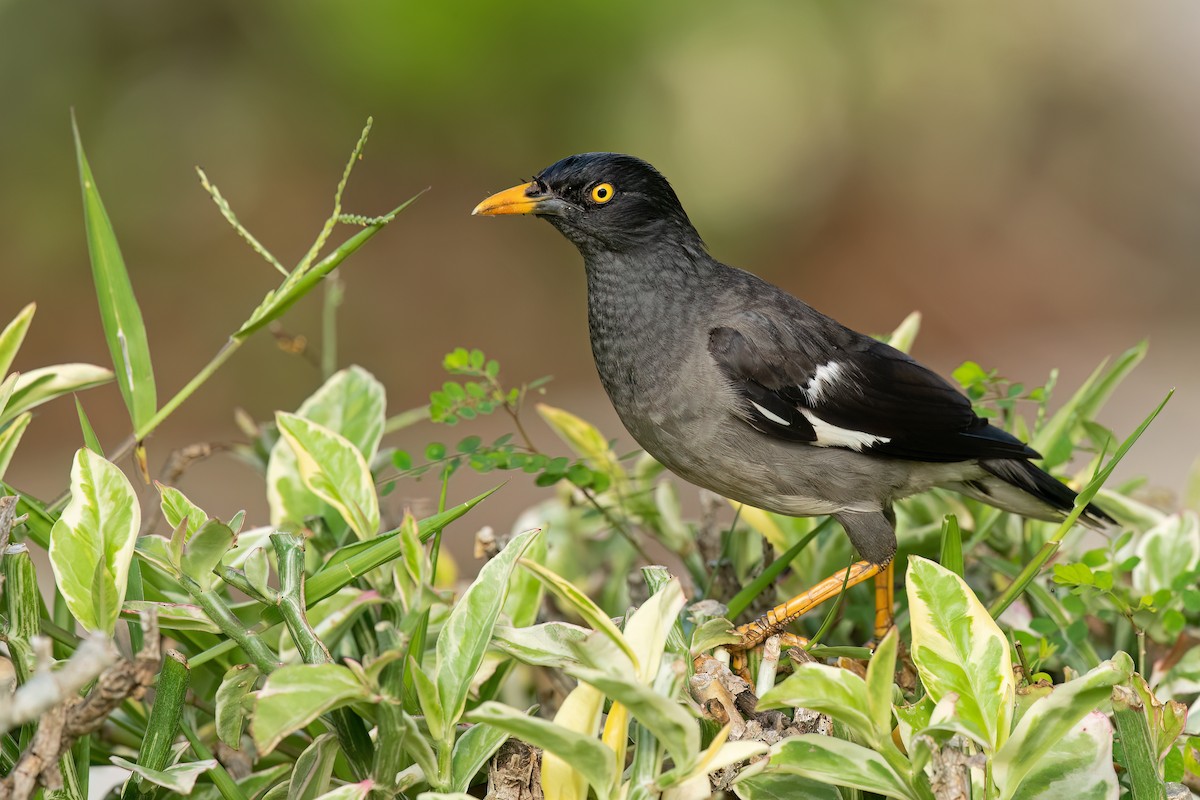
top-left (266, 366), bottom-right (386, 527)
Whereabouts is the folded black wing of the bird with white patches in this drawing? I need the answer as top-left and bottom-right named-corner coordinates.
top-left (708, 313), bottom-right (1039, 462)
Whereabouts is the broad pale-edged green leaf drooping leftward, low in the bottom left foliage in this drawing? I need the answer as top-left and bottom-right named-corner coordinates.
top-left (251, 663), bottom-right (371, 756)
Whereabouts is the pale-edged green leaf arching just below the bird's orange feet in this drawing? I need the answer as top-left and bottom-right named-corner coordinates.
top-left (757, 663), bottom-right (890, 746)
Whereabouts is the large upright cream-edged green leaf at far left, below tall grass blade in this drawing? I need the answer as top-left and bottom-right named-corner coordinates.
top-left (49, 450), bottom-right (142, 636)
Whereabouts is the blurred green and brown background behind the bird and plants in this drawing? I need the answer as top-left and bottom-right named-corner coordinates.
top-left (0, 0), bottom-right (1200, 532)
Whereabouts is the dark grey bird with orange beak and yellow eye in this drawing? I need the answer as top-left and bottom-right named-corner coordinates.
top-left (472, 152), bottom-right (1112, 646)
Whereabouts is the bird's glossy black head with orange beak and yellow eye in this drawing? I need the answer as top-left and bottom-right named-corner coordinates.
top-left (473, 152), bottom-right (701, 255)
